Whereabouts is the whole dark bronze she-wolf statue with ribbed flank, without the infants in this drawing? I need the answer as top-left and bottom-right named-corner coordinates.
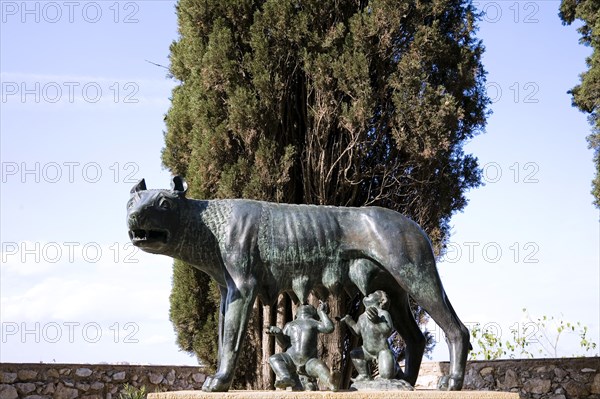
top-left (127, 176), bottom-right (470, 391)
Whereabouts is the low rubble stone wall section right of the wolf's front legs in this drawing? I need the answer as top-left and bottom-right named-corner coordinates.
top-left (417, 357), bottom-right (600, 399)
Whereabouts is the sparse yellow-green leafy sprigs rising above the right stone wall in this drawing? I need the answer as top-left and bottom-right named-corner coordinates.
top-left (470, 309), bottom-right (597, 360)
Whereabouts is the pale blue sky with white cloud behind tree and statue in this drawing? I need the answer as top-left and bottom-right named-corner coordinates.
top-left (0, 0), bottom-right (600, 365)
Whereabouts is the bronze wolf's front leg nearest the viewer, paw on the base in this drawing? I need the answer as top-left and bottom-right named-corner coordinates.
top-left (202, 281), bottom-right (256, 392)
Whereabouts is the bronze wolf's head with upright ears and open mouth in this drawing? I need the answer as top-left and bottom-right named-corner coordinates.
top-left (127, 176), bottom-right (187, 254)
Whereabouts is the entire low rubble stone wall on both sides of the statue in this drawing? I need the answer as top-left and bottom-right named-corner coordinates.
top-left (0, 357), bottom-right (600, 399)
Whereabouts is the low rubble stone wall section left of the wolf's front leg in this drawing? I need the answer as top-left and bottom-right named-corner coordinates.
top-left (0, 363), bottom-right (205, 399)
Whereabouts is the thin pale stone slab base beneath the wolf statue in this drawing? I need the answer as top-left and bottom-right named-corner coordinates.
top-left (148, 390), bottom-right (519, 399)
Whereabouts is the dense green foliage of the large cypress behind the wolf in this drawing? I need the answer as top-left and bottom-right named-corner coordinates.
top-left (162, 0), bottom-right (489, 388)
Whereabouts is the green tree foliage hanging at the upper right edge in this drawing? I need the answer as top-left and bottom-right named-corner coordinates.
top-left (559, 0), bottom-right (600, 208)
